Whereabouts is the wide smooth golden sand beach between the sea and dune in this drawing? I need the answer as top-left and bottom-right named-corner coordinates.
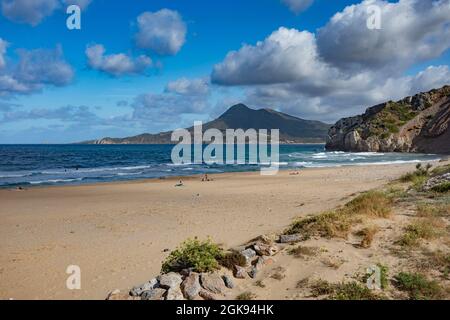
top-left (0, 164), bottom-right (428, 299)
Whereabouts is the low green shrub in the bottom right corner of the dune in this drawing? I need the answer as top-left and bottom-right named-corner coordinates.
top-left (395, 272), bottom-right (442, 300)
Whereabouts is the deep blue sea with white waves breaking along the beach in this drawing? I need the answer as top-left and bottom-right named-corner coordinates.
top-left (0, 144), bottom-right (441, 188)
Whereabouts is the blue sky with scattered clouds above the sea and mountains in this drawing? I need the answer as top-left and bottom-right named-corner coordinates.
top-left (0, 0), bottom-right (450, 143)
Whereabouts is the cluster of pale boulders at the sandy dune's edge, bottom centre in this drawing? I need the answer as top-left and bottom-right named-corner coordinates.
top-left (107, 235), bottom-right (301, 300)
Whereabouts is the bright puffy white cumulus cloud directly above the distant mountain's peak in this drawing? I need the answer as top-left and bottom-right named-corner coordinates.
top-left (212, 27), bottom-right (327, 85)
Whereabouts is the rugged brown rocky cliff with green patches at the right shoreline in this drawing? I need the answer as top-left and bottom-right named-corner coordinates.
top-left (326, 86), bottom-right (450, 154)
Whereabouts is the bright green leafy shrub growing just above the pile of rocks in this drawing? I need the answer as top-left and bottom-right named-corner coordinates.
top-left (162, 239), bottom-right (223, 273)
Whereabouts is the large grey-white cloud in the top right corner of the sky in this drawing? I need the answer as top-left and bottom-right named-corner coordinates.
top-left (317, 0), bottom-right (450, 71)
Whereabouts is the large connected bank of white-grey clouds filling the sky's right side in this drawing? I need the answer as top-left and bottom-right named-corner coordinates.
top-left (211, 0), bottom-right (450, 121)
